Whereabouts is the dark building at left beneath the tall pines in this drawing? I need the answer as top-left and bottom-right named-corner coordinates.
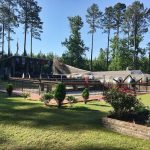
top-left (0, 56), bottom-right (53, 78)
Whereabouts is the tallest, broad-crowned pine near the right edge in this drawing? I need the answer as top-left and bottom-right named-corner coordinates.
top-left (127, 1), bottom-right (150, 69)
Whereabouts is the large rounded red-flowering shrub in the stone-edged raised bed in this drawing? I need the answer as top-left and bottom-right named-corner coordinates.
top-left (104, 88), bottom-right (142, 117)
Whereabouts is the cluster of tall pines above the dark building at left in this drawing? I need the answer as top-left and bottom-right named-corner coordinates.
top-left (0, 0), bottom-right (43, 57)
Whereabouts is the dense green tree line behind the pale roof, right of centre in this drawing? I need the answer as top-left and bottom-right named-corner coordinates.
top-left (62, 1), bottom-right (150, 72)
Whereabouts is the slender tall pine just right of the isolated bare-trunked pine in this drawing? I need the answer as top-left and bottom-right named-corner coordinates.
top-left (102, 7), bottom-right (114, 70)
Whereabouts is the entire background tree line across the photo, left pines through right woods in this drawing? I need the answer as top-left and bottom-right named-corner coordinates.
top-left (0, 0), bottom-right (150, 72)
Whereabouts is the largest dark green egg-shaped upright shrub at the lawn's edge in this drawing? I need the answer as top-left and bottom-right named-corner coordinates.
top-left (54, 83), bottom-right (66, 108)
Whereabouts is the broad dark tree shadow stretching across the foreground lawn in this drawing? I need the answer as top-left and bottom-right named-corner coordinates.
top-left (0, 97), bottom-right (107, 130)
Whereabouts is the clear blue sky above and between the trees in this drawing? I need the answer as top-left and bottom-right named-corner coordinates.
top-left (9, 0), bottom-right (150, 58)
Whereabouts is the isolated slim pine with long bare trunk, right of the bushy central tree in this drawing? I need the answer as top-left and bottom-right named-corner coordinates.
top-left (86, 4), bottom-right (102, 71)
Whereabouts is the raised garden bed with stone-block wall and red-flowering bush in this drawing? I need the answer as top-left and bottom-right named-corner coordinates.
top-left (102, 87), bottom-right (150, 139)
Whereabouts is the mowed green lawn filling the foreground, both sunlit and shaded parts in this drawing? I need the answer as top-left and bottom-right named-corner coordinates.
top-left (0, 94), bottom-right (150, 150)
